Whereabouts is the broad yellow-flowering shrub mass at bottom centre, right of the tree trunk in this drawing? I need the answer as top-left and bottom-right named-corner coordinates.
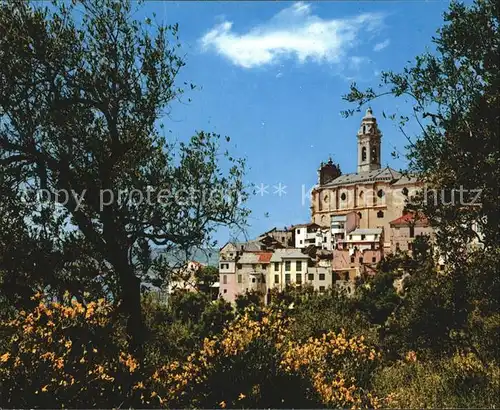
top-left (142, 308), bottom-right (380, 408)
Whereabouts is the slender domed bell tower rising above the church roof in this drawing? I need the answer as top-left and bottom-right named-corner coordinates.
top-left (358, 108), bottom-right (382, 174)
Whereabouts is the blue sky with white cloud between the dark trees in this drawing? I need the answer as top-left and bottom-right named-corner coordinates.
top-left (141, 1), bottom-right (449, 247)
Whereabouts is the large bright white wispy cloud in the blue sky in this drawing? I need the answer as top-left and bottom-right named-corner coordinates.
top-left (200, 2), bottom-right (383, 68)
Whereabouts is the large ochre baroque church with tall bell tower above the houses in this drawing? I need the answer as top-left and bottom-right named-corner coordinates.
top-left (311, 108), bottom-right (421, 252)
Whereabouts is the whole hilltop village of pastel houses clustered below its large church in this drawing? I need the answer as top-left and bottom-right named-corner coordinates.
top-left (219, 109), bottom-right (433, 302)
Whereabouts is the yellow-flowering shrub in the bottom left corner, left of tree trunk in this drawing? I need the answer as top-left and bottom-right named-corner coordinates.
top-left (0, 293), bottom-right (138, 408)
